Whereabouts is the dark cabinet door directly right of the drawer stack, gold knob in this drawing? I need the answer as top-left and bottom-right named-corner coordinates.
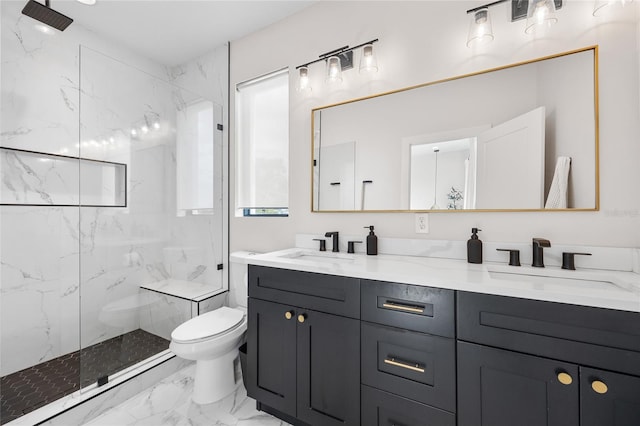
top-left (458, 342), bottom-right (580, 426)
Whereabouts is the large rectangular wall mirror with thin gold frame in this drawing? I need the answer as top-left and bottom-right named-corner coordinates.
top-left (312, 46), bottom-right (598, 212)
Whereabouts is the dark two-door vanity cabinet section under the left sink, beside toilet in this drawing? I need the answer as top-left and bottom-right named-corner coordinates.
top-left (246, 266), bottom-right (360, 426)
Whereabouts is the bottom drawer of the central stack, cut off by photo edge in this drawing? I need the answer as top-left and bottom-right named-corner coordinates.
top-left (361, 385), bottom-right (456, 426)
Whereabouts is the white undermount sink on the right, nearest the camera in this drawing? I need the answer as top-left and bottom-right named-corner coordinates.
top-left (487, 265), bottom-right (640, 292)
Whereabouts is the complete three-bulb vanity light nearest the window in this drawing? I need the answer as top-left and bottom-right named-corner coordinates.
top-left (296, 39), bottom-right (378, 92)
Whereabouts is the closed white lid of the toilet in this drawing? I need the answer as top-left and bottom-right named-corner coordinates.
top-left (171, 306), bottom-right (244, 342)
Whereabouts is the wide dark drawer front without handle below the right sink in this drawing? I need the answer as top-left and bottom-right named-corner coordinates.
top-left (457, 292), bottom-right (640, 375)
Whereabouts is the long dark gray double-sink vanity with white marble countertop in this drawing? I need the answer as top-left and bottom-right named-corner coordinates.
top-left (246, 249), bottom-right (640, 426)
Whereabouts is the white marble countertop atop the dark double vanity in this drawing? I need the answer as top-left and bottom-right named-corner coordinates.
top-left (248, 248), bottom-right (640, 312)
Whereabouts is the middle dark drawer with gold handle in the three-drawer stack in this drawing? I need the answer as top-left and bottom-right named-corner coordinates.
top-left (360, 322), bottom-right (456, 412)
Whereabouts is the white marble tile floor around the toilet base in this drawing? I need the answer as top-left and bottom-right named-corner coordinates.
top-left (84, 364), bottom-right (289, 426)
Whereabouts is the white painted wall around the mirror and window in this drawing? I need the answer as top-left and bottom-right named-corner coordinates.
top-left (230, 1), bottom-right (640, 251)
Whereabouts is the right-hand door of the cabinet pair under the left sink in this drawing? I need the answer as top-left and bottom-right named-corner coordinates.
top-left (297, 310), bottom-right (360, 426)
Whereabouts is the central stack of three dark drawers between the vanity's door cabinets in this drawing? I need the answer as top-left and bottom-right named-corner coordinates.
top-left (361, 280), bottom-right (456, 426)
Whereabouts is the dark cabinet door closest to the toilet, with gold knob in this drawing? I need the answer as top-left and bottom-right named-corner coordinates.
top-left (247, 298), bottom-right (297, 416)
